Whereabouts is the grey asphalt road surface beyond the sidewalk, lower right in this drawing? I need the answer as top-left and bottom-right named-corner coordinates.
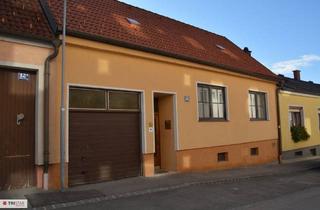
top-left (59, 168), bottom-right (320, 210)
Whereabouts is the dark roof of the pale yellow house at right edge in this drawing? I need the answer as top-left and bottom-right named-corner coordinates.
top-left (280, 76), bottom-right (320, 96)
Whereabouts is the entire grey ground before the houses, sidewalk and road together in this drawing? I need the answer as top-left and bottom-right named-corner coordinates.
top-left (0, 159), bottom-right (320, 209)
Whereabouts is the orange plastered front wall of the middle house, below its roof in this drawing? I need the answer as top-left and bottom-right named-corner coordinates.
top-left (44, 37), bottom-right (278, 187)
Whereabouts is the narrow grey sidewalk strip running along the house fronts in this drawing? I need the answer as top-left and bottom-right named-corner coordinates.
top-left (0, 159), bottom-right (320, 209)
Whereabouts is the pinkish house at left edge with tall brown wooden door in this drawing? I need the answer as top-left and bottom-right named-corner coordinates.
top-left (0, 0), bottom-right (54, 190)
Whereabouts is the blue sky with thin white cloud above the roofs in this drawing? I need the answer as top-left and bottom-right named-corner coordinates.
top-left (121, 0), bottom-right (320, 83)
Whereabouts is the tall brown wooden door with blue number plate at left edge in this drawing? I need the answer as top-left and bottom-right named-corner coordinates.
top-left (0, 69), bottom-right (36, 190)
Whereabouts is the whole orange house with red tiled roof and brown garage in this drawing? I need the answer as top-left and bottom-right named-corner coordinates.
top-left (0, 0), bottom-right (279, 188)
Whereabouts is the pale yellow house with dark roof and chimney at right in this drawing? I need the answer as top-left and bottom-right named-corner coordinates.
top-left (279, 70), bottom-right (320, 160)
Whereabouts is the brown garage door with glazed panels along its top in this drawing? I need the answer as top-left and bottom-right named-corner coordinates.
top-left (69, 88), bottom-right (141, 186)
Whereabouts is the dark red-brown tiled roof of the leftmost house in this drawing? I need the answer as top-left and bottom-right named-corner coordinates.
top-left (0, 0), bottom-right (54, 40)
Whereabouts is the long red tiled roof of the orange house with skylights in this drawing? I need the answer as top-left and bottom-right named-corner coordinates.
top-left (47, 0), bottom-right (275, 78)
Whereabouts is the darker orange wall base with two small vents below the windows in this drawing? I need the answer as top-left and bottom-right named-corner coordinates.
top-left (177, 140), bottom-right (278, 171)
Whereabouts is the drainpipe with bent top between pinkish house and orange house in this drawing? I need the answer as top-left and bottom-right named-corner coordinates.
top-left (43, 39), bottom-right (61, 190)
